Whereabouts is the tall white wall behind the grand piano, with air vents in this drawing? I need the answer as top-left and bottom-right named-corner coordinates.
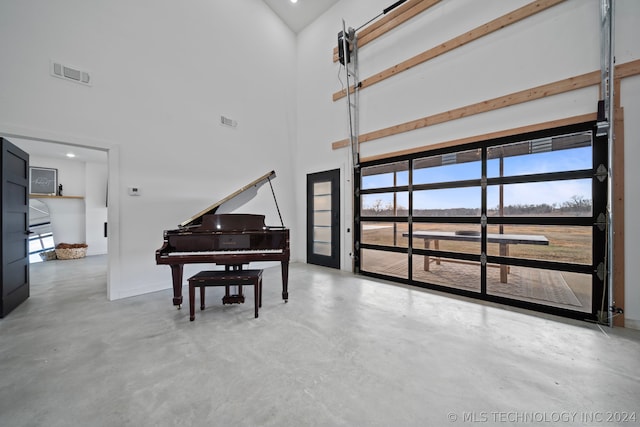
top-left (0, 0), bottom-right (298, 304)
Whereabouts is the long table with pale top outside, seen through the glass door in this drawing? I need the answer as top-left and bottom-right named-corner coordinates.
top-left (402, 230), bottom-right (549, 283)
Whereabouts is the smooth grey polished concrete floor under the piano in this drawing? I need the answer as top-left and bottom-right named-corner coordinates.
top-left (0, 256), bottom-right (640, 427)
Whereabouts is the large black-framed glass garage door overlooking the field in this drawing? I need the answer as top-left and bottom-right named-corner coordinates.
top-left (355, 123), bottom-right (607, 319)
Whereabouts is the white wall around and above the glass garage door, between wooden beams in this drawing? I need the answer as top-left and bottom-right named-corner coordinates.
top-left (295, 0), bottom-right (640, 327)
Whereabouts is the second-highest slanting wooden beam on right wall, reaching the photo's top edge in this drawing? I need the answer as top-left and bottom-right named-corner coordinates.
top-left (333, 0), bottom-right (565, 101)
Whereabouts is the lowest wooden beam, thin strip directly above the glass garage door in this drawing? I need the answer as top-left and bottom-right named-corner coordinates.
top-left (361, 112), bottom-right (598, 162)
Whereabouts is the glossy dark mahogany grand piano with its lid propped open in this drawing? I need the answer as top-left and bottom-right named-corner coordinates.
top-left (156, 171), bottom-right (290, 308)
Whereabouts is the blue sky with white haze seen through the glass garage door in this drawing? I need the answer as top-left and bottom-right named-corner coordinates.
top-left (362, 146), bottom-right (592, 209)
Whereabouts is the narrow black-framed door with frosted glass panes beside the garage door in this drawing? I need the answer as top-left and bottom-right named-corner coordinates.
top-left (307, 169), bottom-right (340, 268)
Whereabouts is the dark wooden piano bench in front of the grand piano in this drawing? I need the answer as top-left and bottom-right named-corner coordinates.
top-left (189, 270), bottom-right (262, 321)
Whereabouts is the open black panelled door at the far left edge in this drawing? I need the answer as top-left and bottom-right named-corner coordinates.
top-left (0, 138), bottom-right (29, 317)
